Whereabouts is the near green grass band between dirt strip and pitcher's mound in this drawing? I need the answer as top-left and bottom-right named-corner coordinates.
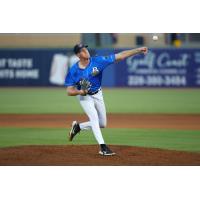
top-left (0, 128), bottom-right (200, 152)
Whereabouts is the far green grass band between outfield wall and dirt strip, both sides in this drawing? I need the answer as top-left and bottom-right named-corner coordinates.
top-left (0, 88), bottom-right (200, 114)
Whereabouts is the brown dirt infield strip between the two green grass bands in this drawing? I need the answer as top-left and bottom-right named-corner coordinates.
top-left (0, 114), bottom-right (200, 130)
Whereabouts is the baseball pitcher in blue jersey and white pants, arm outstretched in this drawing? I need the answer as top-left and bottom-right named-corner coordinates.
top-left (65, 44), bottom-right (148, 156)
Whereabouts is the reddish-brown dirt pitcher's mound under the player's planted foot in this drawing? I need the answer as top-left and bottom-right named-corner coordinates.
top-left (0, 145), bottom-right (200, 166)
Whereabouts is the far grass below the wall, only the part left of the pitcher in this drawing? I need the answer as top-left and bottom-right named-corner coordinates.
top-left (0, 88), bottom-right (81, 113)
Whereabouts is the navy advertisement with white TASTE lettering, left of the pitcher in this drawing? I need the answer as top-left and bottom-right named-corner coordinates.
top-left (0, 49), bottom-right (75, 86)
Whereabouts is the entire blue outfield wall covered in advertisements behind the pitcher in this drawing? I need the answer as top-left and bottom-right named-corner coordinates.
top-left (0, 48), bottom-right (200, 88)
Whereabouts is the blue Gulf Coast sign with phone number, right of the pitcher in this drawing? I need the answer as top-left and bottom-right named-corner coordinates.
top-left (116, 49), bottom-right (200, 87)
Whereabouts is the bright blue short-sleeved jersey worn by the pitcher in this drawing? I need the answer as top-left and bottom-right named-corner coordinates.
top-left (65, 54), bottom-right (115, 92)
